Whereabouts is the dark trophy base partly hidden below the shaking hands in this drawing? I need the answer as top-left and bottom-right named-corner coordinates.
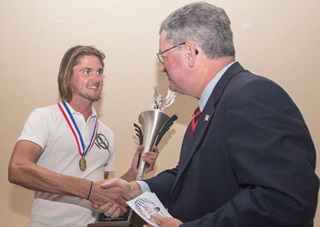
top-left (87, 209), bottom-right (146, 227)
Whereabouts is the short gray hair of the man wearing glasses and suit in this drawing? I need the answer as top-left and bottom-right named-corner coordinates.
top-left (159, 2), bottom-right (235, 59)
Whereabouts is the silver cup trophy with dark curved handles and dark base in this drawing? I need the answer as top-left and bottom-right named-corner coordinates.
top-left (87, 89), bottom-right (178, 227)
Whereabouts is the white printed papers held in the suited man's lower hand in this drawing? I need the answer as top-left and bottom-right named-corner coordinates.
top-left (127, 192), bottom-right (171, 227)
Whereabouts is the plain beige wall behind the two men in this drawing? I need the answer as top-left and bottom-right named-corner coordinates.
top-left (0, 0), bottom-right (320, 226)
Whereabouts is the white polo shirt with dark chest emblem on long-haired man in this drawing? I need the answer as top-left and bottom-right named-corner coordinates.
top-left (18, 104), bottom-right (115, 227)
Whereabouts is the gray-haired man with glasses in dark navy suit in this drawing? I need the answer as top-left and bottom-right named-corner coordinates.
top-left (100, 2), bottom-right (319, 227)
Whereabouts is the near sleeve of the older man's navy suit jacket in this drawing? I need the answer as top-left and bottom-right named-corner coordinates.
top-left (182, 80), bottom-right (319, 226)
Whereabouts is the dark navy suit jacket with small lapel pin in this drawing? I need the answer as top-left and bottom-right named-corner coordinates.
top-left (145, 62), bottom-right (319, 227)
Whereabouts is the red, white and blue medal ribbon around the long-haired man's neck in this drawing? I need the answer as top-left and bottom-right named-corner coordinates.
top-left (58, 101), bottom-right (98, 157)
